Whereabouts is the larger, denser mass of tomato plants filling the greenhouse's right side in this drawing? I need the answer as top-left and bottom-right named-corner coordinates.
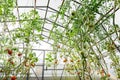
top-left (46, 0), bottom-right (120, 80)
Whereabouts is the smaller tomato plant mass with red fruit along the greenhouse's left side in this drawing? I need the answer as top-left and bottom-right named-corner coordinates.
top-left (0, 0), bottom-right (43, 80)
